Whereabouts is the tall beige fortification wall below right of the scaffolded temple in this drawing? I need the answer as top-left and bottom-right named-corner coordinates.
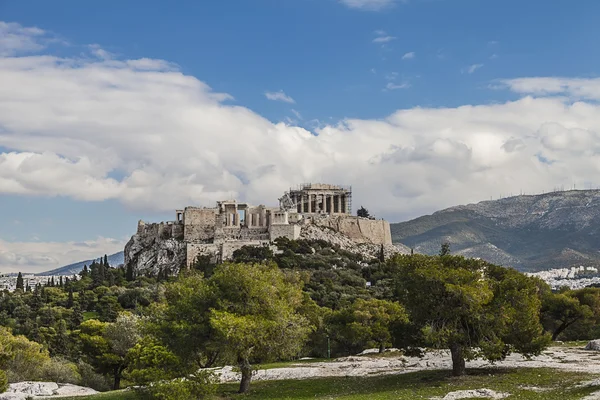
top-left (313, 215), bottom-right (392, 244)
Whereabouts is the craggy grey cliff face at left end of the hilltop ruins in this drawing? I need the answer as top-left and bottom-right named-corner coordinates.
top-left (125, 234), bottom-right (186, 275)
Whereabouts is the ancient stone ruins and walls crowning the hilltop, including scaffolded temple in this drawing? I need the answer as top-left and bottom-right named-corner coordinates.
top-left (125, 183), bottom-right (391, 272)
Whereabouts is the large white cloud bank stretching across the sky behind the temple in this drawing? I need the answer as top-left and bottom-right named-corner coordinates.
top-left (0, 22), bottom-right (600, 231)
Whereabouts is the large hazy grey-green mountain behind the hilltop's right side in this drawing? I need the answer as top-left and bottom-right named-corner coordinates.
top-left (391, 190), bottom-right (600, 271)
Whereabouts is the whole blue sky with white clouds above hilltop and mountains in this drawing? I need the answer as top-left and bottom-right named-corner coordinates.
top-left (0, 0), bottom-right (600, 273)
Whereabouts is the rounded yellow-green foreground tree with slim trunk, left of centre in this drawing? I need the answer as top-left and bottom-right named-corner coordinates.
top-left (209, 264), bottom-right (312, 393)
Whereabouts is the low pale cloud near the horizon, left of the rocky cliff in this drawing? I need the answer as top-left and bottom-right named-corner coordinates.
top-left (0, 237), bottom-right (125, 273)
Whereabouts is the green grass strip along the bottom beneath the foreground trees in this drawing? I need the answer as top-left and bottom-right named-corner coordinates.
top-left (54, 368), bottom-right (600, 400)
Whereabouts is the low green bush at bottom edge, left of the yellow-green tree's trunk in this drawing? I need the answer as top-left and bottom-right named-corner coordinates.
top-left (142, 371), bottom-right (216, 400)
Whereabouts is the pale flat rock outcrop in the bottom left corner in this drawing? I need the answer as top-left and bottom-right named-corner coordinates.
top-left (0, 382), bottom-right (98, 400)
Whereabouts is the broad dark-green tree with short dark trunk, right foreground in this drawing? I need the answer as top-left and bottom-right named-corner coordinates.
top-left (392, 255), bottom-right (550, 376)
